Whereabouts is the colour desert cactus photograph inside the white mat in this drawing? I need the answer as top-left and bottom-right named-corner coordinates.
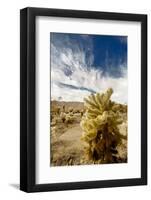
top-left (50, 32), bottom-right (128, 167)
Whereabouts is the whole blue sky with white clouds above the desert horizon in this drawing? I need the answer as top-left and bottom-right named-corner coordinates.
top-left (50, 33), bottom-right (127, 103)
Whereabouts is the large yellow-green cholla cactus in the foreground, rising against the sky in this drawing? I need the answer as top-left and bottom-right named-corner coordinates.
top-left (81, 88), bottom-right (126, 163)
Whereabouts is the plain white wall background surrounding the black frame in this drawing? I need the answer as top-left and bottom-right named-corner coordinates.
top-left (0, 0), bottom-right (151, 200)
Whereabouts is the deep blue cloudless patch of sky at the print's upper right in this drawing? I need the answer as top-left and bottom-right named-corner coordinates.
top-left (93, 36), bottom-right (127, 77)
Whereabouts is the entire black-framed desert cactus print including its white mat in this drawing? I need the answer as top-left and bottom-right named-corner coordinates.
top-left (20, 8), bottom-right (147, 192)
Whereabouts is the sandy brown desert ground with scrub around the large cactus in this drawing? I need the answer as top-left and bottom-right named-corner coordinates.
top-left (50, 101), bottom-right (127, 166)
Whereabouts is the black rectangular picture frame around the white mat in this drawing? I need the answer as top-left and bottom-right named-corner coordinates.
top-left (20, 7), bottom-right (147, 192)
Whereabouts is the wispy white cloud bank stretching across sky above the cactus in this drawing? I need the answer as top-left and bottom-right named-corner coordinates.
top-left (51, 35), bottom-right (128, 103)
